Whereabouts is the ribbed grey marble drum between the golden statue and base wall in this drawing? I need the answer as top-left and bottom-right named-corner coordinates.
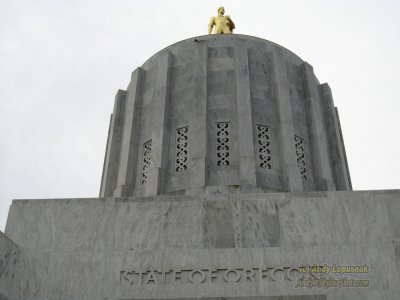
top-left (100, 35), bottom-right (351, 197)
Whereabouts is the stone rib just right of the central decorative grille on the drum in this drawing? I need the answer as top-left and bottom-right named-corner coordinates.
top-left (235, 40), bottom-right (257, 186)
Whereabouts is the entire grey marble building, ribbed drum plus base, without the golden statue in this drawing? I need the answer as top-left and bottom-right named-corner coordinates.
top-left (0, 35), bottom-right (400, 300)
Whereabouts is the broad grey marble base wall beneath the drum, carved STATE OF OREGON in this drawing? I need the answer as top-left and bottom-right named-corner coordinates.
top-left (0, 187), bottom-right (400, 299)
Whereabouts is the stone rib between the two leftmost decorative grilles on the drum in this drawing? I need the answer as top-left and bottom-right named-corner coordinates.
top-left (145, 51), bottom-right (172, 196)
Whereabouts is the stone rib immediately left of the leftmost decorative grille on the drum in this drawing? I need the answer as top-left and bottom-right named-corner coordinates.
top-left (114, 68), bottom-right (144, 197)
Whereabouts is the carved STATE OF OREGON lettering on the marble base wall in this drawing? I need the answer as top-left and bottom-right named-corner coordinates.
top-left (120, 267), bottom-right (300, 286)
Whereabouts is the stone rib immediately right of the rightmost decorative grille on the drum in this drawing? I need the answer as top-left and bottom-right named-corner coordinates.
top-left (302, 62), bottom-right (336, 191)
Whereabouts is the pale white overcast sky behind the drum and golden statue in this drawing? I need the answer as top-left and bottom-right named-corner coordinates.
top-left (0, 0), bottom-right (400, 231)
